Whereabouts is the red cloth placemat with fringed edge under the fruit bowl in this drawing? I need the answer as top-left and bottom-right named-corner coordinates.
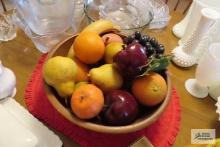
top-left (25, 54), bottom-right (180, 147)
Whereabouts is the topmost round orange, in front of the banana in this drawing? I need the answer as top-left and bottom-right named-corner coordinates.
top-left (73, 31), bottom-right (105, 64)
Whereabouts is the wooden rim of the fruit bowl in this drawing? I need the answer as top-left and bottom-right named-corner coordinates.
top-left (44, 35), bottom-right (172, 134)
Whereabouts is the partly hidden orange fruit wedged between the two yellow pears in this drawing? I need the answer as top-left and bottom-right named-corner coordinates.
top-left (73, 57), bottom-right (89, 83)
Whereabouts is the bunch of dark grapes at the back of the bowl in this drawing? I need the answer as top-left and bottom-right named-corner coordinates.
top-left (124, 31), bottom-right (165, 58)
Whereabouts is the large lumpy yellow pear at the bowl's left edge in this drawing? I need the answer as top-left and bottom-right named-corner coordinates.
top-left (43, 56), bottom-right (77, 98)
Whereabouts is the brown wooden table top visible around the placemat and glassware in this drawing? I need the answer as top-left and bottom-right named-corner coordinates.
top-left (0, 12), bottom-right (220, 147)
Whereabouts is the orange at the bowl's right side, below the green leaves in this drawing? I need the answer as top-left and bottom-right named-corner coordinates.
top-left (132, 72), bottom-right (167, 106)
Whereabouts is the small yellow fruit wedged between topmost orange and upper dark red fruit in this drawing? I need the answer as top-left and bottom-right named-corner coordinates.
top-left (104, 42), bottom-right (125, 64)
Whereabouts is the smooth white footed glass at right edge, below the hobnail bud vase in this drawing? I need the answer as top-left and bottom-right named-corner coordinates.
top-left (185, 43), bottom-right (220, 98)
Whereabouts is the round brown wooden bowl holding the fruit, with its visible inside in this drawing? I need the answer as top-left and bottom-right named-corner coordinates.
top-left (45, 36), bottom-right (171, 134)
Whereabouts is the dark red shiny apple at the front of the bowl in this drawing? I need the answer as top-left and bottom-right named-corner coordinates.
top-left (103, 90), bottom-right (138, 126)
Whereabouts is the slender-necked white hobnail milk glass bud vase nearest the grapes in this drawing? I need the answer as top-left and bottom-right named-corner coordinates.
top-left (172, 8), bottom-right (220, 67)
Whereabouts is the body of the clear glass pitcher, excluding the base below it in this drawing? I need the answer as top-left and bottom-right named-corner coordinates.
top-left (14, 0), bottom-right (74, 35)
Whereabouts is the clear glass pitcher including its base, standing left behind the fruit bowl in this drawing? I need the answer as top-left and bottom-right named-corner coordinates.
top-left (13, 0), bottom-right (75, 53)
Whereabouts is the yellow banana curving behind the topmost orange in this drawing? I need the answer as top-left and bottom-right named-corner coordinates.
top-left (82, 19), bottom-right (120, 34)
